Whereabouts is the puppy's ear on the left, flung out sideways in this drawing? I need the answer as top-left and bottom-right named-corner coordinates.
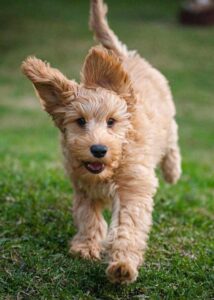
top-left (21, 57), bottom-right (77, 129)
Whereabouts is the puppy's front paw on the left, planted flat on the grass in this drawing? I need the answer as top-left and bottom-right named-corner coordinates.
top-left (69, 241), bottom-right (101, 260)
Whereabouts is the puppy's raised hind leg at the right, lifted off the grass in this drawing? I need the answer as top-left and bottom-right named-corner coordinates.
top-left (161, 120), bottom-right (181, 184)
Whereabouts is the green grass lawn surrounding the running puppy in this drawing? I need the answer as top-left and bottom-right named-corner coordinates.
top-left (0, 0), bottom-right (214, 300)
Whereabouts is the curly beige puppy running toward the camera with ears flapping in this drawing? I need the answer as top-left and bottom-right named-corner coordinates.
top-left (22, 0), bottom-right (181, 283)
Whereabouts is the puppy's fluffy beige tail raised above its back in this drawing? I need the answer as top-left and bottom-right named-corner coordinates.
top-left (89, 0), bottom-right (128, 56)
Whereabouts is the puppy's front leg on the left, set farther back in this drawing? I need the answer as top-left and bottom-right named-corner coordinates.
top-left (70, 194), bottom-right (107, 259)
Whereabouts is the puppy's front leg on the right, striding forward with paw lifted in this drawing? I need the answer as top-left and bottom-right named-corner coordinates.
top-left (106, 169), bottom-right (157, 283)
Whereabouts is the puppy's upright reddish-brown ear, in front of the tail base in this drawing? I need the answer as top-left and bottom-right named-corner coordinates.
top-left (82, 46), bottom-right (132, 99)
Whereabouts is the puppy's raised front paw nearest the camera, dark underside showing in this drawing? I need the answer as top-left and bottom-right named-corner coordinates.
top-left (106, 261), bottom-right (138, 283)
